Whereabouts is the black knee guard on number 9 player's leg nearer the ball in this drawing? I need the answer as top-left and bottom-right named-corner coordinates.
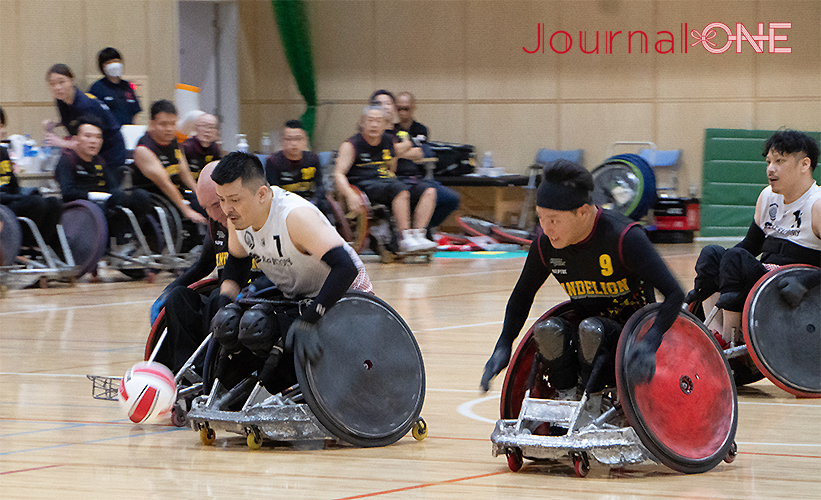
top-left (533, 318), bottom-right (579, 390)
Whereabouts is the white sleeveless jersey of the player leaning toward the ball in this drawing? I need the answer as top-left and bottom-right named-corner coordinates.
top-left (237, 186), bottom-right (373, 298)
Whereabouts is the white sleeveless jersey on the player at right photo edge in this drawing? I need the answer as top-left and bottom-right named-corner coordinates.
top-left (759, 184), bottom-right (821, 250)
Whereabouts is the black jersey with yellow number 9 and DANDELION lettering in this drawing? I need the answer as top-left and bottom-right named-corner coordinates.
top-left (538, 210), bottom-right (655, 324)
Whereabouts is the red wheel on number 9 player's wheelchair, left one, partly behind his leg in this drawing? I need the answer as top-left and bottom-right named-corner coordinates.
top-left (500, 301), bottom-right (579, 419)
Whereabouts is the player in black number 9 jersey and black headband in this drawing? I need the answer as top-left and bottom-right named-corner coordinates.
top-left (481, 160), bottom-right (684, 399)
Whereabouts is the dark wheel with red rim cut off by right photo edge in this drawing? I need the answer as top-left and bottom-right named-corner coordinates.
top-left (741, 264), bottom-right (821, 398)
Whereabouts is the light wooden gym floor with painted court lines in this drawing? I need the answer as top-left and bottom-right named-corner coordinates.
top-left (0, 244), bottom-right (821, 500)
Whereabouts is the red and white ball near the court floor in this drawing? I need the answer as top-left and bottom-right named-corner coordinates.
top-left (117, 361), bottom-right (177, 424)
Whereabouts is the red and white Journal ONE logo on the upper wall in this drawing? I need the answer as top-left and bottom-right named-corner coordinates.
top-left (522, 23), bottom-right (792, 54)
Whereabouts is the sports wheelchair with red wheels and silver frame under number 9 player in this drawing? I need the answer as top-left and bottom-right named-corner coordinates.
top-left (491, 302), bottom-right (738, 477)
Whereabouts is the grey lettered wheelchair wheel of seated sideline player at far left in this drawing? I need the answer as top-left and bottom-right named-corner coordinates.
top-left (60, 200), bottom-right (108, 278)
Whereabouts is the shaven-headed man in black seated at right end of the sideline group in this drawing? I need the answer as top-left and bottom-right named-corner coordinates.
top-left (394, 92), bottom-right (459, 232)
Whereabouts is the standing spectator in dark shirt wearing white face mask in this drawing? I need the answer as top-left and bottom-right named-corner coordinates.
top-left (88, 47), bottom-right (142, 125)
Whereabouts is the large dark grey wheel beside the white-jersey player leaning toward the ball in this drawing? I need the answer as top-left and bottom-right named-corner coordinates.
top-left (295, 292), bottom-right (425, 447)
